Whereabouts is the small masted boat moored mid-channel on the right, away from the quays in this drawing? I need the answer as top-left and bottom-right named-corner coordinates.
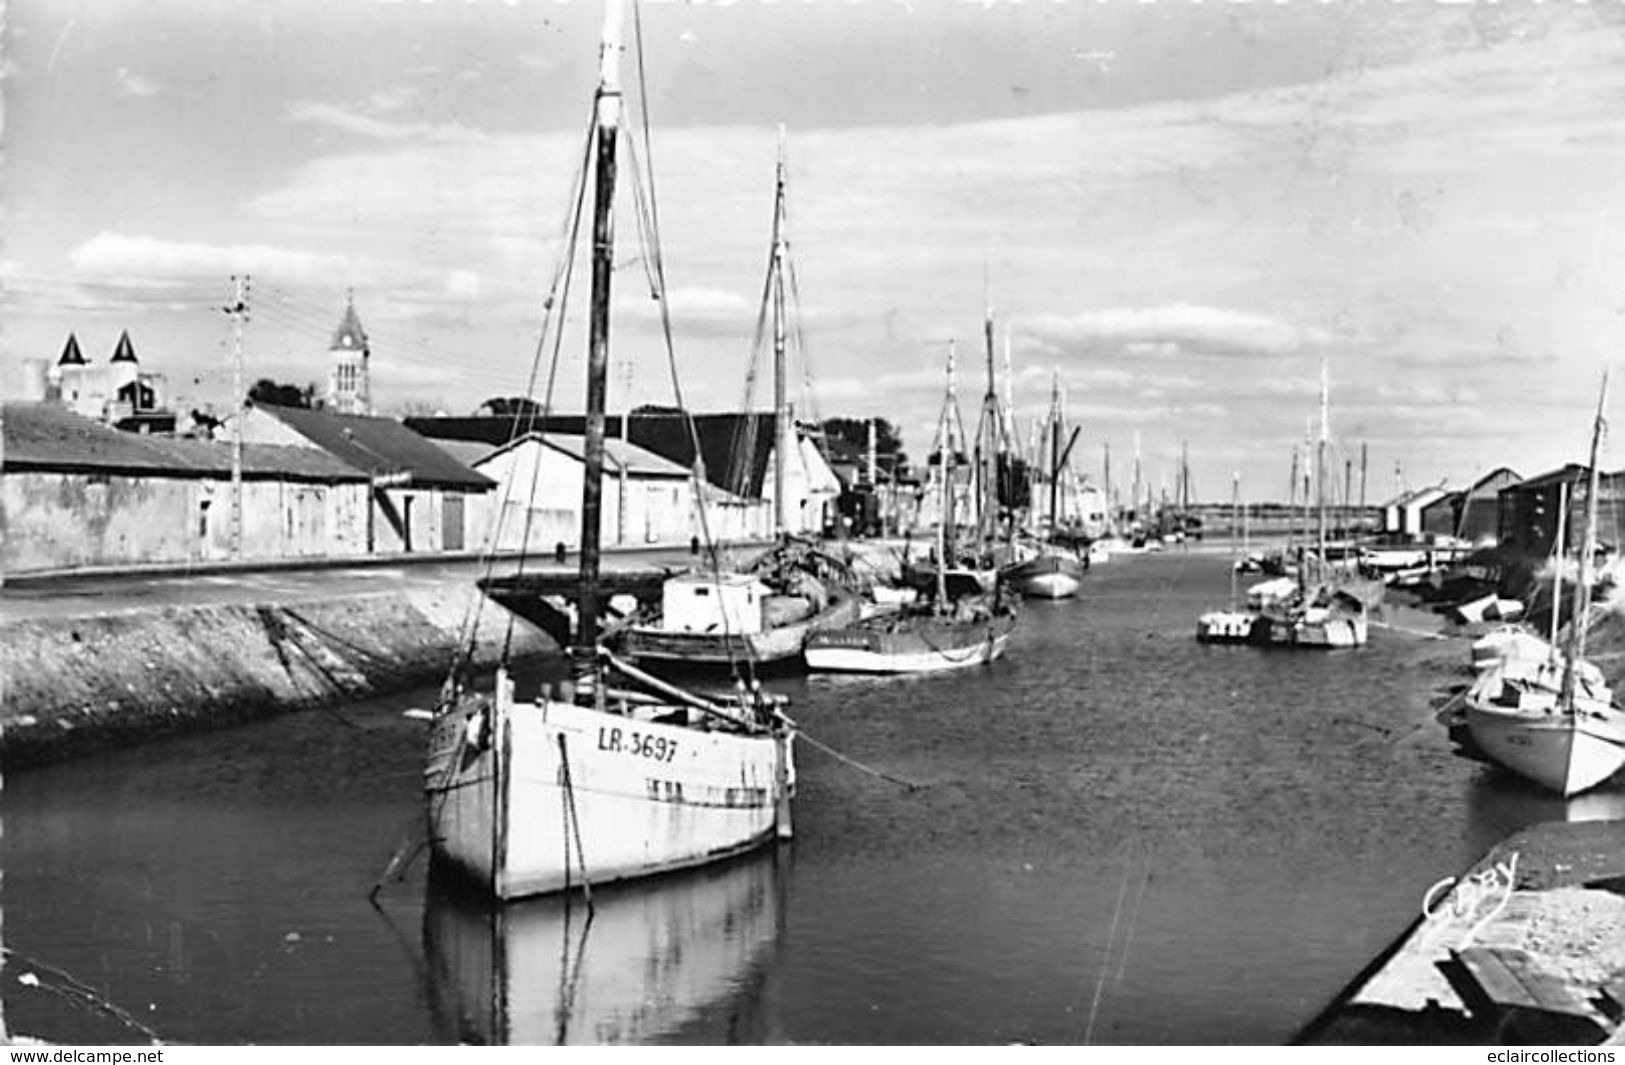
top-left (1255, 363), bottom-right (1381, 647)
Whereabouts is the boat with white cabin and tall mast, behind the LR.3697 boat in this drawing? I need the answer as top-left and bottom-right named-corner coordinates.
top-left (622, 128), bottom-right (863, 667)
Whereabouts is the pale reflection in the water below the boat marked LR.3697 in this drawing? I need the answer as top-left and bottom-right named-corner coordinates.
top-left (424, 850), bottom-right (788, 1045)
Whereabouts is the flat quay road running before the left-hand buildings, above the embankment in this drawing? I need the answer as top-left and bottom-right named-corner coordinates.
top-left (0, 546), bottom-right (718, 623)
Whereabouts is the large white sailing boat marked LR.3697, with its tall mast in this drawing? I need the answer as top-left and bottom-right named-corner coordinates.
top-left (424, 0), bottom-right (795, 899)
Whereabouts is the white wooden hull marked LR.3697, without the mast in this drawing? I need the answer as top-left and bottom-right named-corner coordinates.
top-left (426, 699), bottom-right (795, 899)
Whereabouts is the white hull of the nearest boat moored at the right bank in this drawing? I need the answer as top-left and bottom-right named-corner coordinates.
top-left (1467, 701), bottom-right (1625, 798)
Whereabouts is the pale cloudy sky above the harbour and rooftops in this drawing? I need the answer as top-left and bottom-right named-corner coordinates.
top-left (0, 0), bottom-right (1625, 501)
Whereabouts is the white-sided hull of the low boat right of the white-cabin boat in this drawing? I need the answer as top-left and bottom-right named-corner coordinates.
top-left (806, 616), bottom-right (1014, 673)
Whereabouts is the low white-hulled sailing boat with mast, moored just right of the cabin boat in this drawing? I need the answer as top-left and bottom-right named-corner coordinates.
top-left (804, 346), bottom-right (1016, 673)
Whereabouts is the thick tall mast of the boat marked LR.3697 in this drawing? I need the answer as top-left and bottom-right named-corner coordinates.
top-left (575, 0), bottom-right (621, 672)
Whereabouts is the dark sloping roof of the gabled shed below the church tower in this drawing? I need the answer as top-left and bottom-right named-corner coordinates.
top-left (255, 403), bottom-right (494, 491)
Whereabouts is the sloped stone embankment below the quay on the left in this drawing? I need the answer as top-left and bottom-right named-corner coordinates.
top-left (0, 589), bottom-right (554, 767)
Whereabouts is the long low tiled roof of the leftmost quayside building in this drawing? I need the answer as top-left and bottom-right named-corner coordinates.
top-left (0, 403), bottom-right (367, 485)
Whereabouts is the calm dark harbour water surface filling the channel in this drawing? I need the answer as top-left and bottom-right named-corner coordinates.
top-left (3, 553), bottom-right (1625, 1044)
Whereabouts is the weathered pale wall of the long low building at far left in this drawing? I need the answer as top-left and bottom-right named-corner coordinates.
top-left (0, 473), bottom-right (366, 572)
